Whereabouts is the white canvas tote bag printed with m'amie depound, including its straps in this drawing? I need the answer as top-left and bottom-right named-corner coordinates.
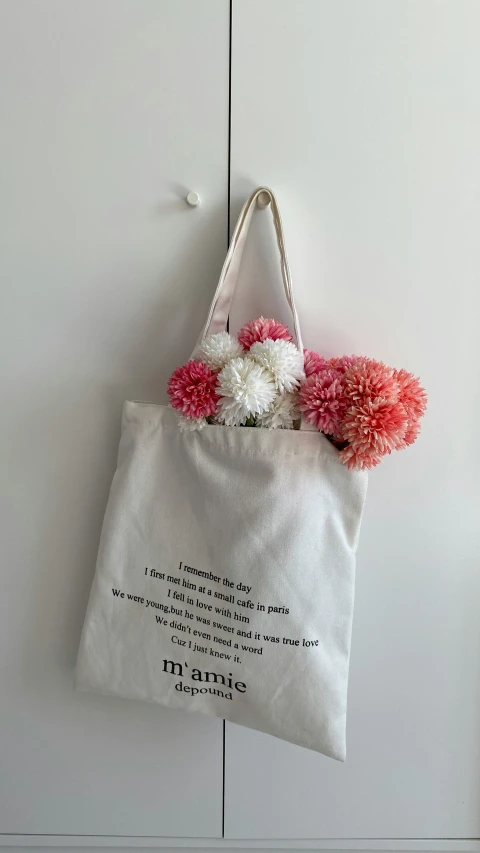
top-left (76, 188), bottom-right (367, 760)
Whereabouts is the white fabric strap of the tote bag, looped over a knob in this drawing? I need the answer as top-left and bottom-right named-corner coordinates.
top-left (194, 187), bottom-right (303, 352)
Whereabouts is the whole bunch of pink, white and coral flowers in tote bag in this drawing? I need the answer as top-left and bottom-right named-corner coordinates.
top-left (168, 317), bottom-right (427, 469)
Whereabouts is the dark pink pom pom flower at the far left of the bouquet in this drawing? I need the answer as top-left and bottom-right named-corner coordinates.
top-left (168, 361), bottom-right (219, 418)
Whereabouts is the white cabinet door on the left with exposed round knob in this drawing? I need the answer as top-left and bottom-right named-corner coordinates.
top-left (0, 0), bottom-right (229, 836)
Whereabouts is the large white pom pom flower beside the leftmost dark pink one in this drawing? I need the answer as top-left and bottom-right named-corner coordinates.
top-left (216, 358), bottom-right (276, 426)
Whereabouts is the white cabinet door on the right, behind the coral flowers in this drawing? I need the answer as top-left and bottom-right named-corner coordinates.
top-left (225, 0), bottom-right (480, 849)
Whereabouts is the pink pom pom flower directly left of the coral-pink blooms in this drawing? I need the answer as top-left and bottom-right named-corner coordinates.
top-left (298, 370), bottom-right (348, 435)
